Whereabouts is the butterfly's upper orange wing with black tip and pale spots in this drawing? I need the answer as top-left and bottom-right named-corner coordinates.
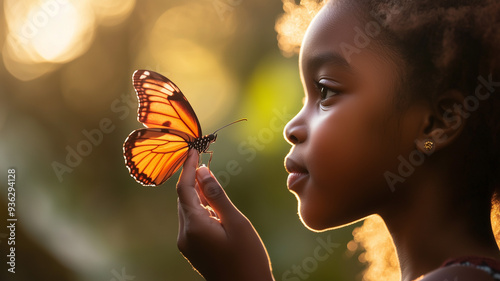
top-left (132, 70), bottom-right (201, 138)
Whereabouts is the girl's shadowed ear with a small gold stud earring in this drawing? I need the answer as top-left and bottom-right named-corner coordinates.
top-left (416, 90), bottom-right (471, 154)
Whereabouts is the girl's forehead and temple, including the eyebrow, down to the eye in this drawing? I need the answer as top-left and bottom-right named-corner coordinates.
top-left (299, 1), bottom-right (402, 102)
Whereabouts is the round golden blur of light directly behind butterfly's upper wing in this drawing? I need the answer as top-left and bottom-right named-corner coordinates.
top-left (143, 3), bottom-right (237, 128)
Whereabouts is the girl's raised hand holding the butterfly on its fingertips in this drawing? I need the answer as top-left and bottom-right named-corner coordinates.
top-left (177, 149), bottom-right (274, 281)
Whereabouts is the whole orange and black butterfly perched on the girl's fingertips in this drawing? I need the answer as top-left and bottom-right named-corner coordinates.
top-left (123, 70), bottom-right (246, 186)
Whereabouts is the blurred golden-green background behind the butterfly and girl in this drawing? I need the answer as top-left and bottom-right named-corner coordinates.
top-left (0, 0), bottom-right (386, 281)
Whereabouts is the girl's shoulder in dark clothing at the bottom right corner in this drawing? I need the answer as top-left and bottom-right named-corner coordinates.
top-left (419, 257), bottom-right (500, 281)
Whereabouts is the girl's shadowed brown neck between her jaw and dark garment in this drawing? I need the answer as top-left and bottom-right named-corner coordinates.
top-left (380, 165), bottom-right (500, 281)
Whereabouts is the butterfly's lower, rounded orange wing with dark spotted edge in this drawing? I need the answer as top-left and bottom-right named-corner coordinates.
top-left (123, 128), bottom-right (194, 186)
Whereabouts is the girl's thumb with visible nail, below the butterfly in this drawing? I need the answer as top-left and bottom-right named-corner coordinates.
top-left (196, 166), bottom-right (239, 221)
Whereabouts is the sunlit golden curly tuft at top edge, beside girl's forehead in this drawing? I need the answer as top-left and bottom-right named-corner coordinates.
top-left (275, 0), bottom-right (326, 57)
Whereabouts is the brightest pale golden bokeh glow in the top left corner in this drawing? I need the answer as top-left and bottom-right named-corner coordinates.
top-left (2, 0), bottom-right (135, 81)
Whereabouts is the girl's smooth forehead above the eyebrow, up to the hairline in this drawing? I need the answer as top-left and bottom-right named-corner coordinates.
top-left (299, 1), bottom-right (395, 76)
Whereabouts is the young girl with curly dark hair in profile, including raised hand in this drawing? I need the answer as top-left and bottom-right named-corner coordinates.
top-left (177, 0), bottom-right (500, 281)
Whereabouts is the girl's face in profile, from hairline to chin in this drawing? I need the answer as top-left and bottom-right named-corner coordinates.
top-left (285, 1), bottom-right (425, 230)
